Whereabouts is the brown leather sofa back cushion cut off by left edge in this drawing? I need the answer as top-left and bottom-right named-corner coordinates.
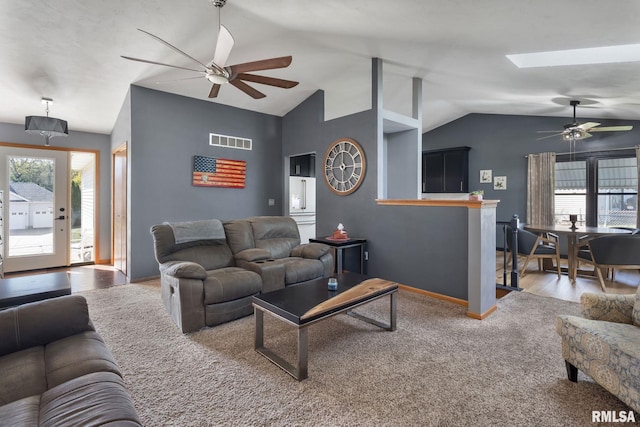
top-left (0, 346), bottom-right (47, 404)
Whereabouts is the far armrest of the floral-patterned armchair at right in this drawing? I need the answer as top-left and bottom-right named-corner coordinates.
top-left (580, 292), bottom-right (635, 324)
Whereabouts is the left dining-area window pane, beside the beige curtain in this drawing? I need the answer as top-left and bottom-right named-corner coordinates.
top-left (555, 161), bottom-right (587, 226)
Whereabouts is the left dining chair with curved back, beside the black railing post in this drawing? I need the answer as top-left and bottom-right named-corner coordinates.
top-left (507, 227), bottom-right (560, 278)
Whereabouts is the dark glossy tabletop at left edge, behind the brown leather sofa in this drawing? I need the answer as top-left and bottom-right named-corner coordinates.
top-left (0, 272), bottom-right (71, 310)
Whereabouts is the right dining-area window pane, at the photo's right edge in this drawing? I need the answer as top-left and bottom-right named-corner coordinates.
top-left (598, 157), bottom-right (638, 228)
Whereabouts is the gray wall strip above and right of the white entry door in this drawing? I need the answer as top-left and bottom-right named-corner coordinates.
top-left (0, 119), bottom-right (111, 261)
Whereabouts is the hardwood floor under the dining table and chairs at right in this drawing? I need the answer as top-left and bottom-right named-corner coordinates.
top-left (496, 251), bottom-right (640, 302)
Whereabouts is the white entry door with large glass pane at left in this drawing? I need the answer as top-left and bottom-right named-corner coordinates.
top-left (0, 146), bottom-right (69, 272)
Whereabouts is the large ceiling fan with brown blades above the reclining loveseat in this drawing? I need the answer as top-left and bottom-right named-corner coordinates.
top-left (122, 1), bottom-right (298, 99)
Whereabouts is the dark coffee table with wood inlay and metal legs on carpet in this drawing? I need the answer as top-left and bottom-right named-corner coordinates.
top-left (253, 273), bottom-right (398, 381)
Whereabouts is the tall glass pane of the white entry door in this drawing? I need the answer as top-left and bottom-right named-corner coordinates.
top-left (7, 156), bottom-right (55, 257)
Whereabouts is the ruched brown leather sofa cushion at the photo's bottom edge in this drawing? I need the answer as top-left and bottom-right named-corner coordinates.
top-left (39, 372), bottom-right (141, 427)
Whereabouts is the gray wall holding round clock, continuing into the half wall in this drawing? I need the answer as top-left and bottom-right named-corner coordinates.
top-left (283, 91), bottom-right (467, 299)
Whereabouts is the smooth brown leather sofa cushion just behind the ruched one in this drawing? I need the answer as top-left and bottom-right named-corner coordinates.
top-left (44, 331), bottom-right (120, 388)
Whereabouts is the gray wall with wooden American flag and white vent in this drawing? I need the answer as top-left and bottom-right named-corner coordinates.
top-left (129, 86), bottom-right (283, 280)
